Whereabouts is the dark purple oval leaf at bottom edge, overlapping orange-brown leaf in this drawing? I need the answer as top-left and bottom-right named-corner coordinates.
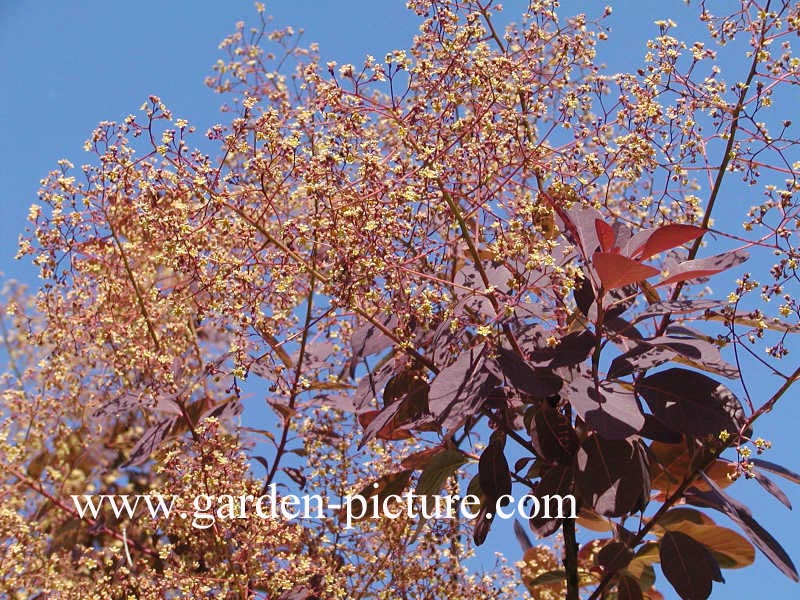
top-left (660, 531), bottom-right (725, 600)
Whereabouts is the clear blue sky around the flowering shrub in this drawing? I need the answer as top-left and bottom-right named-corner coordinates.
top-left (0, 0), bottom-right (800, 599)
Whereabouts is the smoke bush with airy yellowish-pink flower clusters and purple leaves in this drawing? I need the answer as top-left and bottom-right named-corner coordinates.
top-left (0, 0), bottom-right (800, 599)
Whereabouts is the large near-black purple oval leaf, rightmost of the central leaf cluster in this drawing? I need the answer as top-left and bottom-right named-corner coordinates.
top-left (636, 368), bottom-right (745, 437)
